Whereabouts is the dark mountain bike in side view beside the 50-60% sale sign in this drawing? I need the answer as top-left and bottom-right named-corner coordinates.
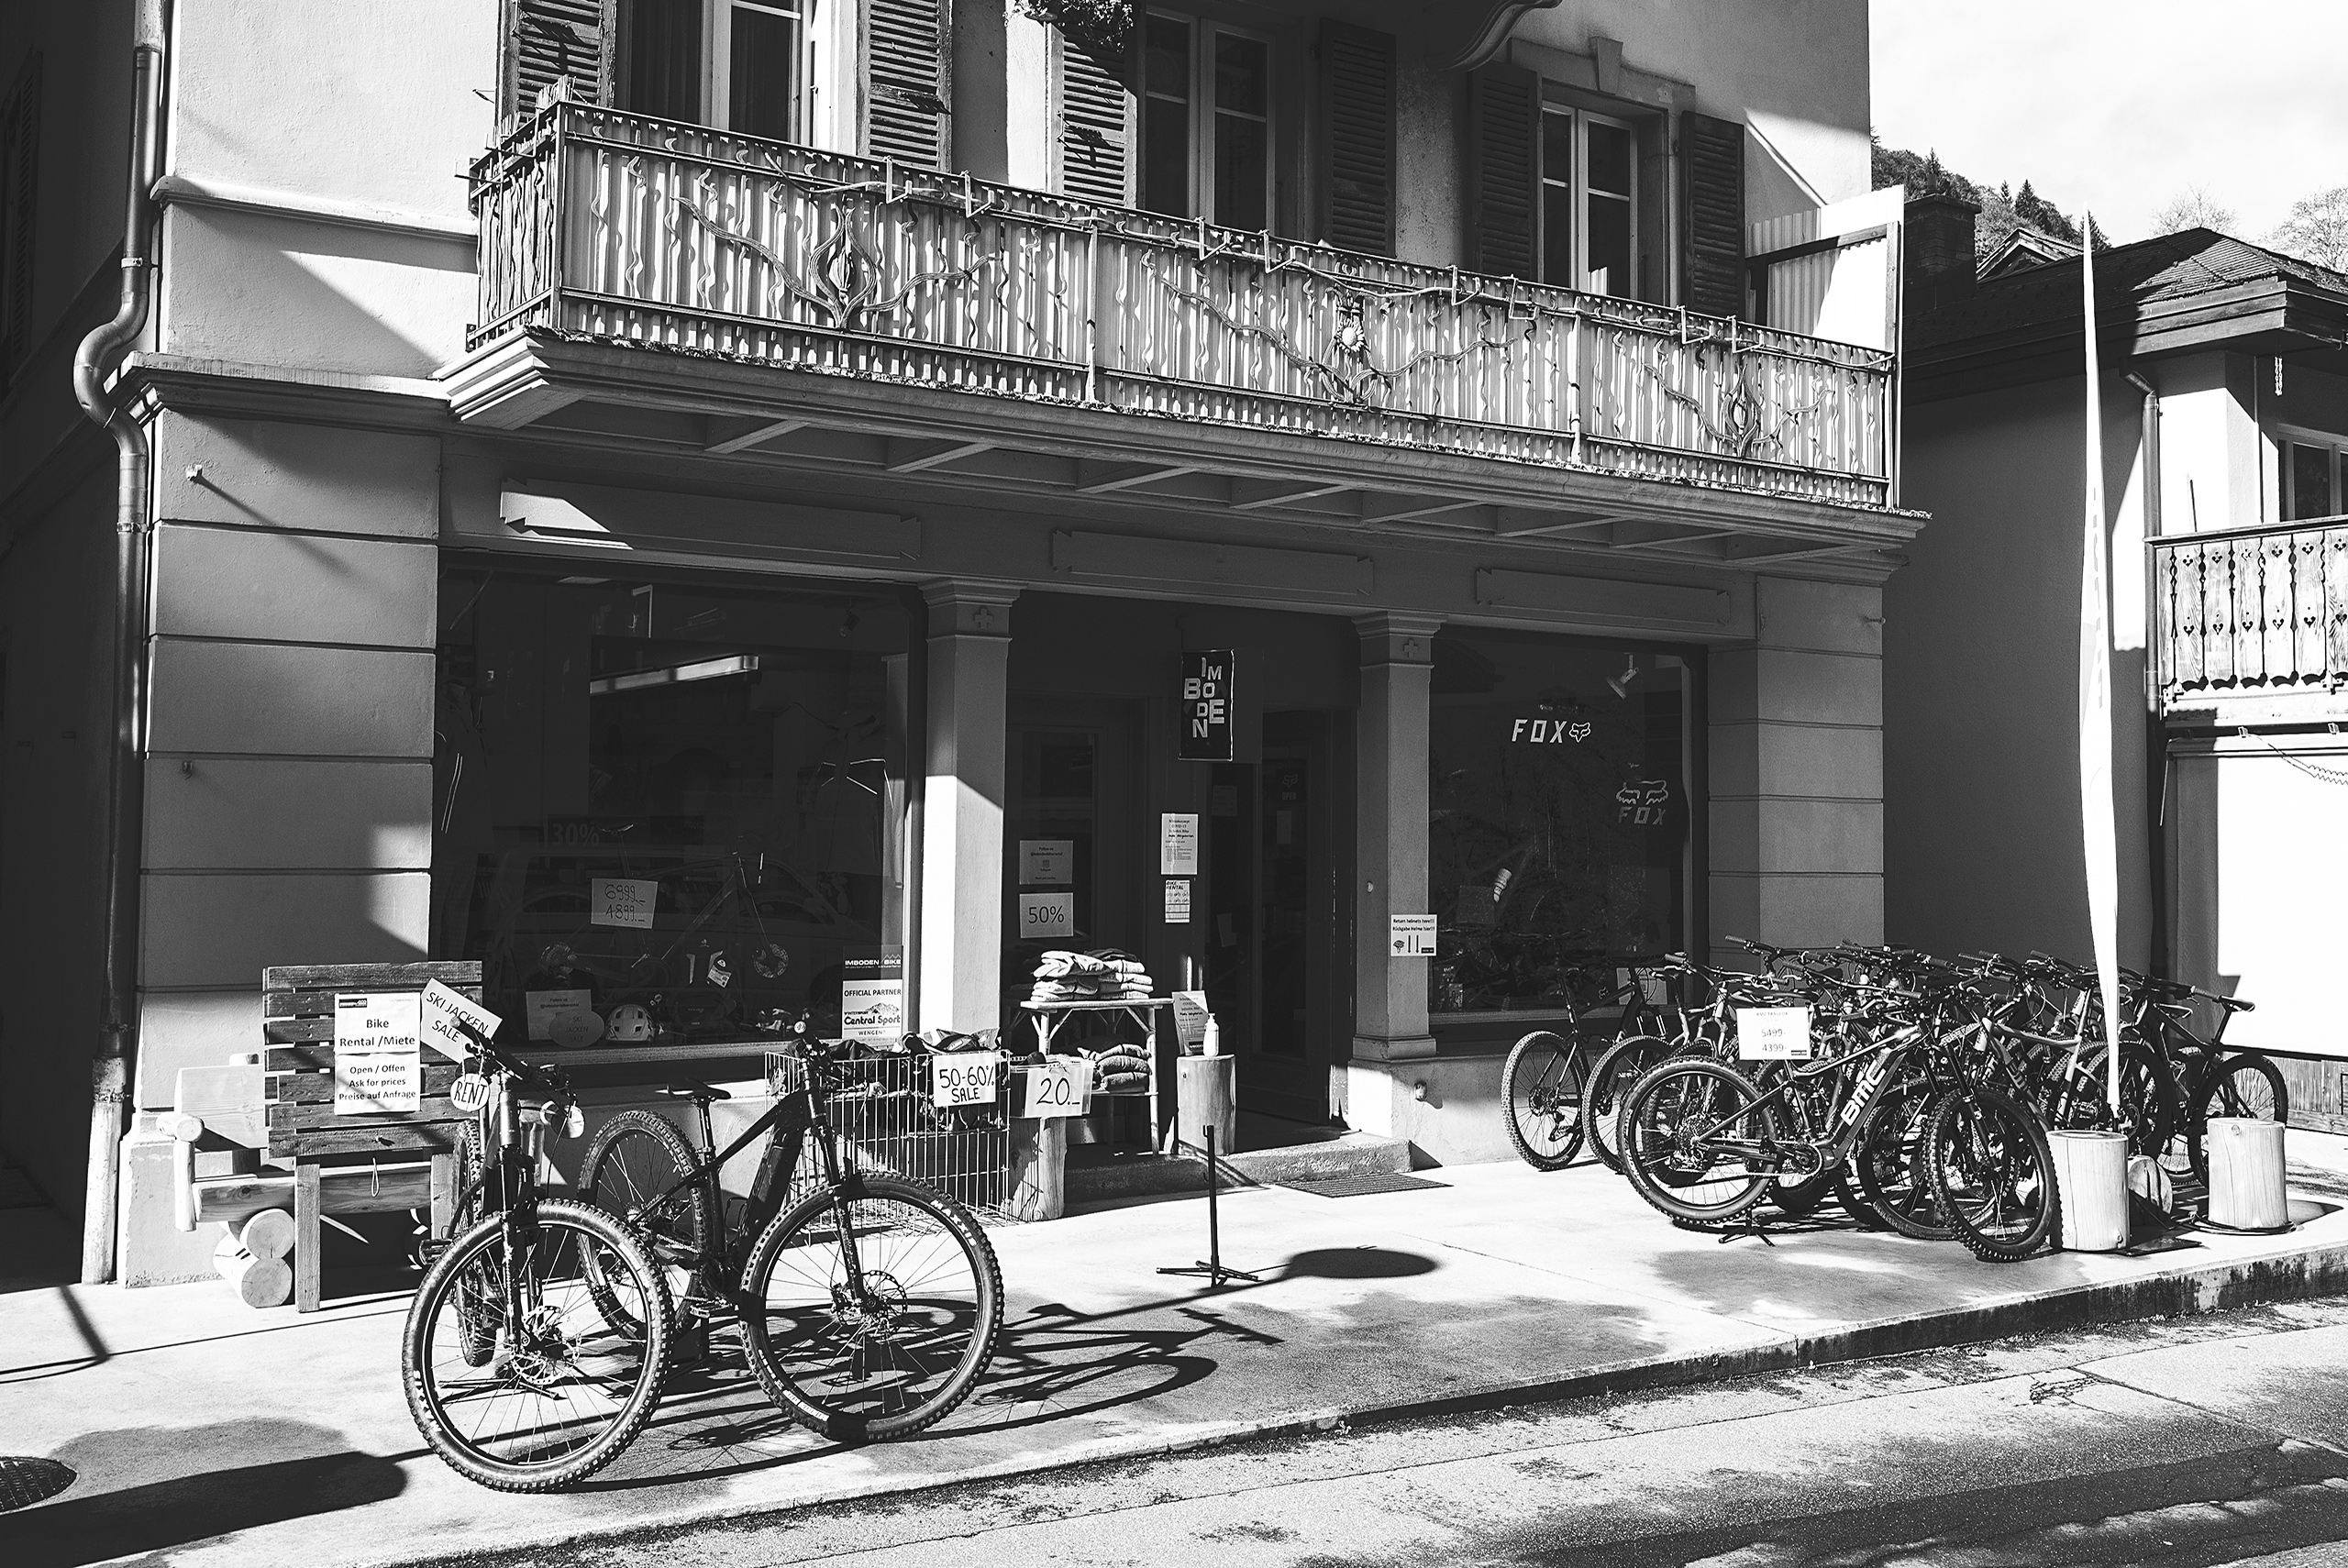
top-left (580, 1040), bottom-right (1002, 1443)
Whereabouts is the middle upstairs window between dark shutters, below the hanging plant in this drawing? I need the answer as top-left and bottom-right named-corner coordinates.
top-left (1141, 12), bottom-right (1273, 230)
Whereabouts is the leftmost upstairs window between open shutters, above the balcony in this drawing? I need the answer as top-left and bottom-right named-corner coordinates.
top-left (617, 0), bottom-right (814, 141)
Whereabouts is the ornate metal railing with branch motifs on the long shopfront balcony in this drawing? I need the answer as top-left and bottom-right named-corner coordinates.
top-left (470, 104), bottom-right (1892, 507)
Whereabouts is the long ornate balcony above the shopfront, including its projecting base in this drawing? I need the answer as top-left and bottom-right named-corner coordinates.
top-left (453, 104), bottom-right (1916, 563)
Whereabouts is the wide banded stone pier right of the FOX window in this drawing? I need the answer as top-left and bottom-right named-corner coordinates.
top-left (1710, 578), bottom-right (1883, 967)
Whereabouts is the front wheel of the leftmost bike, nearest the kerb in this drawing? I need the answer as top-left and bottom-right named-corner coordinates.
top-left (402, 1199), bottom-right (670, 1493)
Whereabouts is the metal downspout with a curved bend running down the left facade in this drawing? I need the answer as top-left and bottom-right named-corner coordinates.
top-left (72, 0), bottom-right (164, 1284)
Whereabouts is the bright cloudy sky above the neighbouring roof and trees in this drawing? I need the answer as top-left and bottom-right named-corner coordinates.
top-left (1866, 0), bottom-right (2348, 242)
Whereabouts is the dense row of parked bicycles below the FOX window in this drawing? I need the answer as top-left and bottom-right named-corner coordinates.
top-left (1502, 939), bottom-right (2289, 1261)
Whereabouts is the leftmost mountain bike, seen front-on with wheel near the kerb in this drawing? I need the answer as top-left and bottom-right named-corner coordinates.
top-left (399, 1037), bottom-right (670, 1493)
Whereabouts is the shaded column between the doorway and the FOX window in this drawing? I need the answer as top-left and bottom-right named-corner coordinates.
top-left (1353, 613), bottom-right (1442, 1061)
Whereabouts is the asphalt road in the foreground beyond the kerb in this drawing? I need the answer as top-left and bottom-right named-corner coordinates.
top-left (451, 1300), bottom-right (2348, 1568)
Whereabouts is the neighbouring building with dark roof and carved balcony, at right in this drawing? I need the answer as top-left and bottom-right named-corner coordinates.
top-left (1883, 202), bottom-right (2348, 1112)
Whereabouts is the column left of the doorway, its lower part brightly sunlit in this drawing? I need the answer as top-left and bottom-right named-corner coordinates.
top-left (918, 580), bottom-right (1019, 1031)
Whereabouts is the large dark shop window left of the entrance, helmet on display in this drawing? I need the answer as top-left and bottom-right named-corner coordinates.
top-left (432, 570), bottom-right (911, 1044)
